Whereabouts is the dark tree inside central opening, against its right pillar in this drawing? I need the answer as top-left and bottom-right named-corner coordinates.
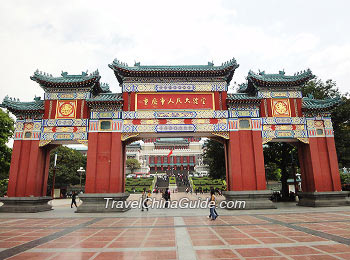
top-left (203, 139), bottom-right (226, 179)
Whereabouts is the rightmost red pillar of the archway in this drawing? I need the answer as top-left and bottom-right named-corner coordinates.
top-left (298, 137), bottom-right (341, 192)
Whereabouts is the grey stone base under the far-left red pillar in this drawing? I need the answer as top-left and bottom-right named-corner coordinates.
top-left (0, 197), bottom-right (52, 213)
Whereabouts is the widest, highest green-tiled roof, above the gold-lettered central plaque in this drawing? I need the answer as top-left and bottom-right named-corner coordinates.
top-left (108, 59), bottom-right (239, 83)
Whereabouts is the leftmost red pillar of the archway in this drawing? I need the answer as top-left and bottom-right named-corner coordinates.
top-left (7, 140), bottom-right (50, 197)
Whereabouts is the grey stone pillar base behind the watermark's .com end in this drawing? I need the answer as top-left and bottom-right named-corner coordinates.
top-left (223, 190), bottom-right (276, 209)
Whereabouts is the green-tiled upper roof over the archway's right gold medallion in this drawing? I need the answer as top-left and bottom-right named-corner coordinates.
top-left (238, 69), bottom-right (315, 93)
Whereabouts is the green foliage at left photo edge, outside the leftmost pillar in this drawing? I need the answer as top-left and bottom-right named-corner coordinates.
top-left (0, 109), bottom-right (14, 180)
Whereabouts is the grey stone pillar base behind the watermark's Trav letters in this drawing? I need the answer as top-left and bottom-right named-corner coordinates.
top-left (76, 193), bottom-right (130, 213)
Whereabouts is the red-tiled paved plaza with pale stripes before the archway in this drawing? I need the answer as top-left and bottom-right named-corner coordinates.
top-left (0, 194), bottom-right (350, 260)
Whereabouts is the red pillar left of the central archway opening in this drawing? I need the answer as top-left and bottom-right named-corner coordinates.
top-left (85, 132), bottom-right (126, 193)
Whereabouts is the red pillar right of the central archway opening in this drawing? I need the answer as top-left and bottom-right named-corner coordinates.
top-left (225, 130), bottom-right (266, 191)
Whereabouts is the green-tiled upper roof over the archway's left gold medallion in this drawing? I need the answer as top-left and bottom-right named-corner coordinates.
top-left (30, 70), bottom-right (110, 94)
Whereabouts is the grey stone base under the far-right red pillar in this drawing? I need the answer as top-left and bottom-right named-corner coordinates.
top-left (297, 191), bottom-right (350, 207)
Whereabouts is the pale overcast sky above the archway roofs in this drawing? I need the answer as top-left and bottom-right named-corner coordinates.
top-left (0, 0), bottom-right (350, 101)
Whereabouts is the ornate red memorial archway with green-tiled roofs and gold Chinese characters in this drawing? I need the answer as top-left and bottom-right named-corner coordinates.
top-left (1, 59), bottom-right (346, 212)
